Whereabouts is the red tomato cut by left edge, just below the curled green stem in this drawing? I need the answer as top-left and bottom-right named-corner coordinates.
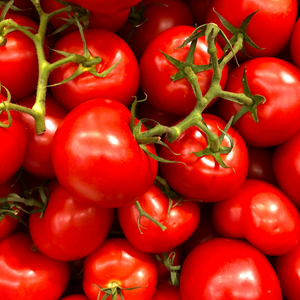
top-left (0, 94), bottom-right (28, 184)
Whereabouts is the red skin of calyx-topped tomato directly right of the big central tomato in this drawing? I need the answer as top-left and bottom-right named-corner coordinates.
top-left (159, 114), bottom-right (249, 202)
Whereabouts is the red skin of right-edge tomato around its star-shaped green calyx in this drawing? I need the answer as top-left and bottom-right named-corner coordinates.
top-left (218, 57), bottom-right (300, 147)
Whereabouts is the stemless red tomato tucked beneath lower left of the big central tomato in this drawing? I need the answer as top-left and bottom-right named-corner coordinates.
top-left (29, 185), bottom-right (114, 261)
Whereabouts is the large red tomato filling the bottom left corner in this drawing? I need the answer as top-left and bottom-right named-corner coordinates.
top-left (0, 232), bottom-right (70, 300)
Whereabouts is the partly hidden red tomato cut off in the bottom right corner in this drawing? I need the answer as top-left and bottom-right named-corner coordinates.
top-left (275, 241), bottom-right (300, 300)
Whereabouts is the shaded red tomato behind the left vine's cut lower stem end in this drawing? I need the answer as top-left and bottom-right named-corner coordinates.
top-left (18, 93), bottom-right (68, 179)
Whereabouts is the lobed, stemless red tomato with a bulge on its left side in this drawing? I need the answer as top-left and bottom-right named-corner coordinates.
top-left (212, 179), bottom-right (300, 256)
